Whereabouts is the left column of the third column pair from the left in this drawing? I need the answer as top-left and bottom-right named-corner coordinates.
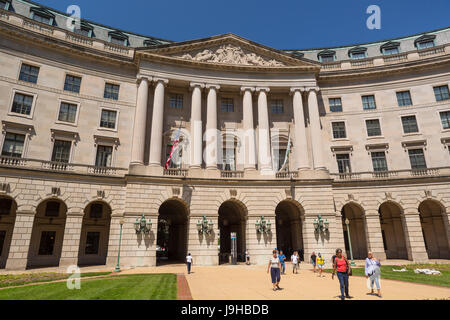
top-left (241, 87), bottom-right (256, 171)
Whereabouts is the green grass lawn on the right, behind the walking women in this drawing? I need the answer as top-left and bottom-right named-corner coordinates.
top-left (325, 264), bottom-right (450, 287)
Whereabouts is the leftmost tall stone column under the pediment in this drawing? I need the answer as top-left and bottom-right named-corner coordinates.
top-left (130, 77), bottom-right (148, 165)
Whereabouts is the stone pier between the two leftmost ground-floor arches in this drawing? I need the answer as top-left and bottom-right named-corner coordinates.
top-left (5, 211), bottom-right (35, 270)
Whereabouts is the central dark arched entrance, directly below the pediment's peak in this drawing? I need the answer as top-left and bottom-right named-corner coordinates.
top-left (219, 200), bottom-right (247, 264)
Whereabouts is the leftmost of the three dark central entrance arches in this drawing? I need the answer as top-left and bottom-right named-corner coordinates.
top-left (156, 199), bottom-right (189, 264)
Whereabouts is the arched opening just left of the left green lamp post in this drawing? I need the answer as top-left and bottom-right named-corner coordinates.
top-left (78, 201), bottom-right (111, 266)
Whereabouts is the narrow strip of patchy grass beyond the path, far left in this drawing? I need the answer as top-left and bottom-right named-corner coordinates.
top-left (0, 272), bottom-right (110, 288)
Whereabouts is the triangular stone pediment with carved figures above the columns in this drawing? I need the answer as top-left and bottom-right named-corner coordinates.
top-left (138, 34), bottom-right (319, 68)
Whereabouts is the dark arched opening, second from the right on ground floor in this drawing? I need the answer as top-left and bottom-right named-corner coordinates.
top-left (378, 201), bottom-right (408, 259)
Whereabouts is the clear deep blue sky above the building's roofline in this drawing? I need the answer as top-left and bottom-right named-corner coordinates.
top-left (35, 0), bottom-right (450, 49)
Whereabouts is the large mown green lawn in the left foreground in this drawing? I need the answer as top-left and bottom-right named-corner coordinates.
top-left (0, 274), bottom-right (177, 300)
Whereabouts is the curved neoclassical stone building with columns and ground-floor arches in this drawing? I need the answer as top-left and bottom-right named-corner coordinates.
top-left (0, 0), bottom-right (450, 269)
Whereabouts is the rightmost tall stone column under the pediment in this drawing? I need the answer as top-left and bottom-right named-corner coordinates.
top-left (308, 87), bottom-right (325, 170)
